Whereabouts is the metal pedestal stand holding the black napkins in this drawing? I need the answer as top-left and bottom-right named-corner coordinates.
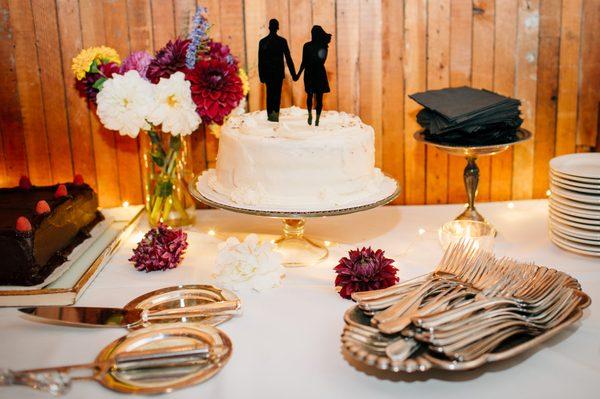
top-left (414, 129), bottom-right (531, 228)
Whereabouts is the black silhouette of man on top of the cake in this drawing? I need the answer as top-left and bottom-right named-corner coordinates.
top-left (258, 19), bottom-right (296, 122)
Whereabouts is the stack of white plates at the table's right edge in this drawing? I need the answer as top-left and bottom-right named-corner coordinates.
top-left (549, 153), bottom-right (600, 257)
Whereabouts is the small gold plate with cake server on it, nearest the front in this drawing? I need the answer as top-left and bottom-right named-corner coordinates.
top-left (0, 325), bottom-right (232, 396)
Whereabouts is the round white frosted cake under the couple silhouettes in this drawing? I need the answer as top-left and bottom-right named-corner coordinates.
top-left (199, 107), bottom-right (395, 207)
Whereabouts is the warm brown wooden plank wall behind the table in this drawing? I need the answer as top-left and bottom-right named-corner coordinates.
top-left (0, 0), bottom-right (600, 206)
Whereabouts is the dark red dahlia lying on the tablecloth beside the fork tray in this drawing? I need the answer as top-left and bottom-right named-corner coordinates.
top-left (333, 247), bottom-right (399, 299)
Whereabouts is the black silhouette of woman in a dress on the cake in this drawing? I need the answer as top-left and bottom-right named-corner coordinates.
top-left (294, 25), bottom-right (331, 126)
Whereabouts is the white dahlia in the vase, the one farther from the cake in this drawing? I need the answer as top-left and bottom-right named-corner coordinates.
top-left (96, 71), bottom-right (155, 137)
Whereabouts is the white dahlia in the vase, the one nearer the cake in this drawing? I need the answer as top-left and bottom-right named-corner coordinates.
top-left (148, 72), bottom-right (202, 136)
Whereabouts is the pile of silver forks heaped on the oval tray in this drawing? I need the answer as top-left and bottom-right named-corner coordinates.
top-left (342, 240), bottom-right (589, 371)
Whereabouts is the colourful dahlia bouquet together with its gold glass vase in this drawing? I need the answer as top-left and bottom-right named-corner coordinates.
top-left (72, 7), bottom-right (249, 226)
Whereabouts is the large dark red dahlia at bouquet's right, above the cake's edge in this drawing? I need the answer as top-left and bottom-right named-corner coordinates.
top-left (185, 59), bottom-right (244, 125)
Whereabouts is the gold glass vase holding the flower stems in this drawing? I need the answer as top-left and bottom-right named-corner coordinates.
top-left (141, 128), bottom-right (195, 227)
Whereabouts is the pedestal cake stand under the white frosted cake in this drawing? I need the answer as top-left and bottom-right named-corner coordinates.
top-left (188, 175), bottom-right (400, 267)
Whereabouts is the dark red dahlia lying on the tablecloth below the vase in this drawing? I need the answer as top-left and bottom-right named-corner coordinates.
top-left (129, 224), bottom-right (188, 272)
